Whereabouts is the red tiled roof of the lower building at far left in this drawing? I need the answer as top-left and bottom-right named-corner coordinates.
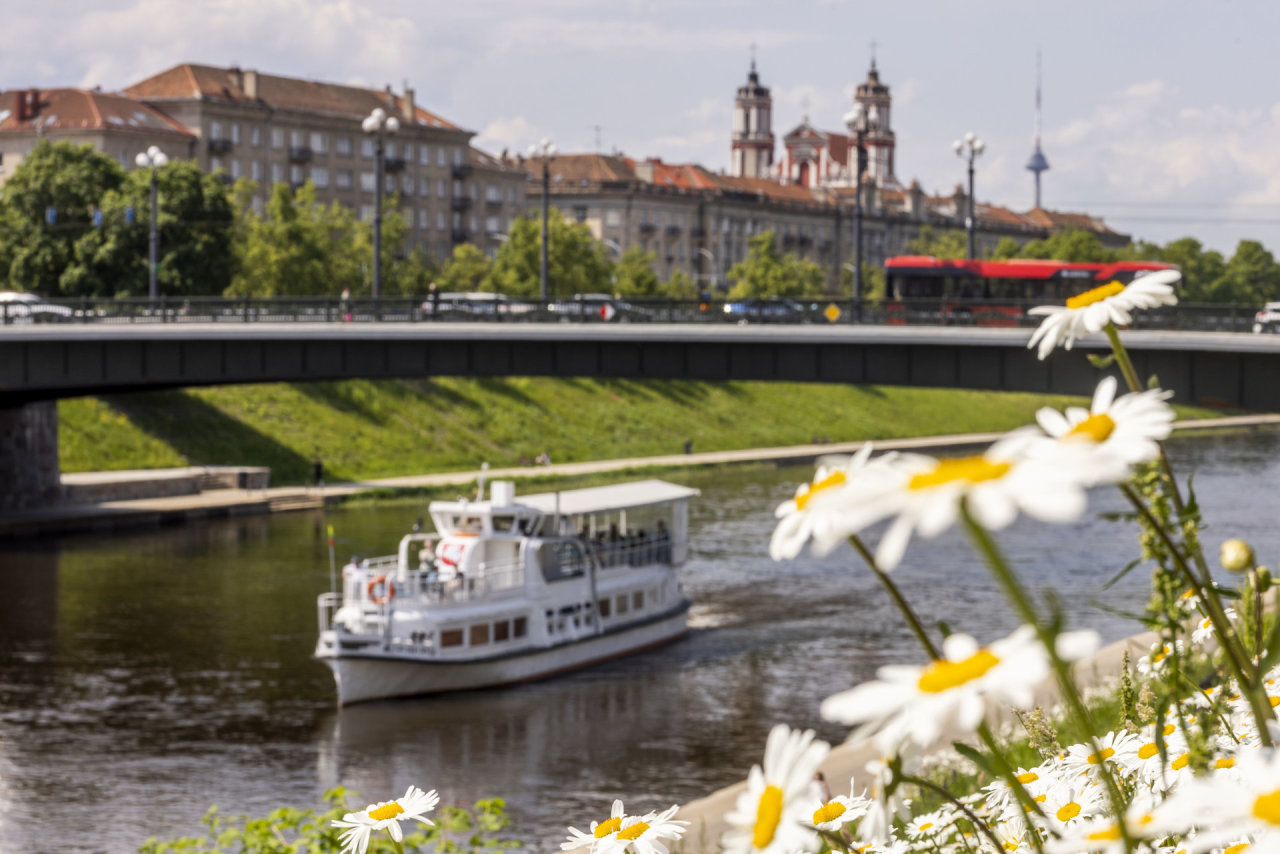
top-left (0, 88), bottom-right (192, 137)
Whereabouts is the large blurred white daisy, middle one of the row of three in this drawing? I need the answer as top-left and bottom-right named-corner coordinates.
top-left (850, 435), bottom-right (1085, 570)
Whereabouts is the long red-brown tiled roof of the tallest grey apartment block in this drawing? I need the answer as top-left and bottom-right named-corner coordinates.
top-left (124, 63), bottom-right (461, 131)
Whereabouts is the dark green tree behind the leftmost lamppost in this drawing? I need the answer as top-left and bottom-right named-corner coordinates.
top-left (63, 160), bottom-right (237, 296)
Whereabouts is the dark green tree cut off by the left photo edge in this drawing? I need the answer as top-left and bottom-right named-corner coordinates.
top-left (0, 141), bottom-right (125, 296)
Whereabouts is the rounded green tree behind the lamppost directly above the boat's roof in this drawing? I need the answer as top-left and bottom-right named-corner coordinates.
top-left (489, 209), bottom-right (613, 297)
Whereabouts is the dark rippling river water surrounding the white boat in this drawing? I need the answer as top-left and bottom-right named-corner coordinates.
top-left (0, 431), bottom-right (1280, 854)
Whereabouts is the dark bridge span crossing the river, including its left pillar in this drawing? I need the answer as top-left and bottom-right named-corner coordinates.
top-left (0, 323), bottom-right (1280, 506)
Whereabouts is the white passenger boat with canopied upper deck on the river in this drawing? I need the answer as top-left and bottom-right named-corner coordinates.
top-left (315, 480), bottom-right (698, 705)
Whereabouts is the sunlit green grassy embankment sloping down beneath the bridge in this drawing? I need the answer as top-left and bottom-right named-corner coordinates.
top-left (59, 379), bottom-right (1215, 484)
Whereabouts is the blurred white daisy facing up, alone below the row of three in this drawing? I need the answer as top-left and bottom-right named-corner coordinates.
top-left (820, 626), bottom-right (1097, 753)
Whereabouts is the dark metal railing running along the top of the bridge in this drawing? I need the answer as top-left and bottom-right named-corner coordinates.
top-left (0, 294), bottom-right (1256, 332)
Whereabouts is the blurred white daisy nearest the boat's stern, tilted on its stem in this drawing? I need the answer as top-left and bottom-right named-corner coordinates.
top-left (769, 442), bottom-right (896, 561)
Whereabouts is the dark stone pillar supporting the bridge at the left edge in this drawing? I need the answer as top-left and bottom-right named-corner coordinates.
top-left (0, 401), bottom-right (61, 510)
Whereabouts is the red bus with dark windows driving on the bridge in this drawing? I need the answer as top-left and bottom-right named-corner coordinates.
top-left (884, 255), bottom-right (1174, 325)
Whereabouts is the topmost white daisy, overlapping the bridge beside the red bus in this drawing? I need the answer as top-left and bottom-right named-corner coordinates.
top-left (1027, 270), bottom-right (1181, 359)
